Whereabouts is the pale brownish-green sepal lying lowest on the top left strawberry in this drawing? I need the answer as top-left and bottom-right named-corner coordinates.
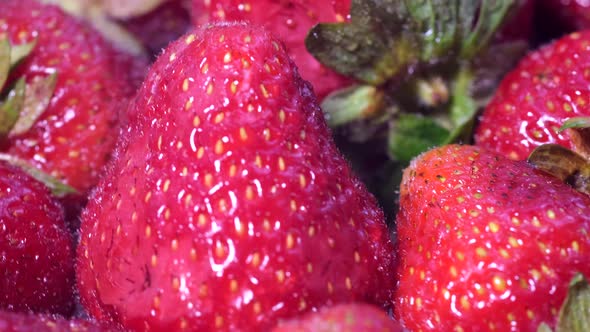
top-left (10, 73), bottom-right (57, 135)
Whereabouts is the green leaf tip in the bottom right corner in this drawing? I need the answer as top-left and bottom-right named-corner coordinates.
top-left (537, 273), bottom-right (590, 332)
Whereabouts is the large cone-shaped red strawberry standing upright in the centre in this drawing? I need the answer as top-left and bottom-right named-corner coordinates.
top-left (77, 23), bottom-right (395, 331)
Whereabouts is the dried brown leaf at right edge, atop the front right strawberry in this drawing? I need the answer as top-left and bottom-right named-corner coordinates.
top-left (527, 144), bottom-right (590, 196)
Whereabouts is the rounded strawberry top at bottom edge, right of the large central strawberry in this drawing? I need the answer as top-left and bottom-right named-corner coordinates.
top-left (272, 303), bottom-right (404, 332)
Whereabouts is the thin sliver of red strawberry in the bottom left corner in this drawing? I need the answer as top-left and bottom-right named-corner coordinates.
top-left (0, 311), bottom-right (118, 332)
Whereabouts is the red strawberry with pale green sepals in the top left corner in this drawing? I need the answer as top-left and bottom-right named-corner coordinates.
top-left (0, 0), bottom-right (140, 192)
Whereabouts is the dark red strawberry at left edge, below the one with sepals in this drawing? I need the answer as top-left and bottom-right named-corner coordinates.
top-left (0, 162), bottom-right (74, 316)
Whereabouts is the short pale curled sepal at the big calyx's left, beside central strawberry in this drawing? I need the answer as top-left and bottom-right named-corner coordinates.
top-left (322, 85), bottom-right (383, 127)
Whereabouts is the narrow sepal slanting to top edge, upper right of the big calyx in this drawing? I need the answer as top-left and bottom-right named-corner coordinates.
top-left (461, 0), bottom-right (518, 59)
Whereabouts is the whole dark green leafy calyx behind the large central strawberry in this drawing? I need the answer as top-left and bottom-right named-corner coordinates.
top-left (305, 0), bottom-right (527, 161)
